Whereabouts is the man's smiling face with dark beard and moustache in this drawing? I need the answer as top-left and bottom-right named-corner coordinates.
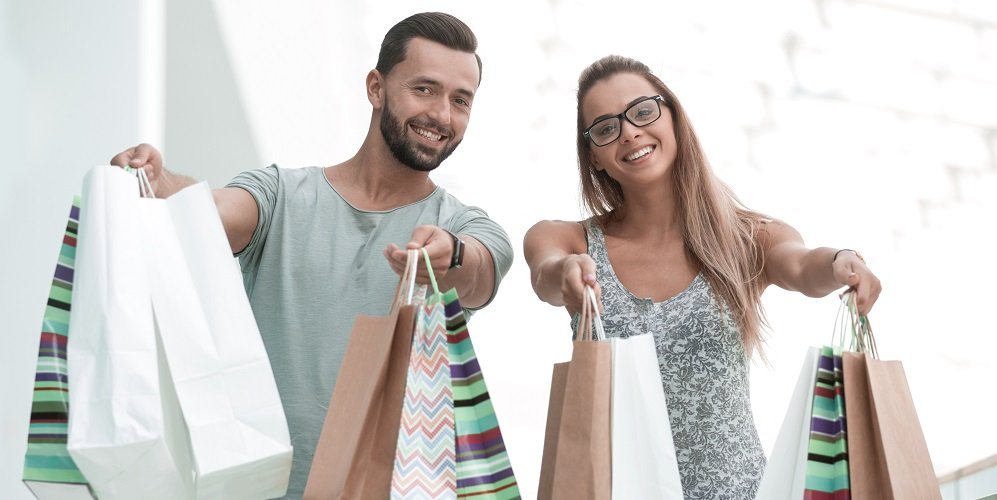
top-left (380, 38), bottom-right (479, 172)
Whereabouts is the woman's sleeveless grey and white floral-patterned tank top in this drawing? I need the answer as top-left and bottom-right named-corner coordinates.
top-left (572, 219), bottom-right (765, 500)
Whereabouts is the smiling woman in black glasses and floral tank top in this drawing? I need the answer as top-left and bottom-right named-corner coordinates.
top-left (524, 56), bottom-right (880, 499)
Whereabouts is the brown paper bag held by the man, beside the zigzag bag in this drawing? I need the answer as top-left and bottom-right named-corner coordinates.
top-left (304, 248), bottom-right (418, 499)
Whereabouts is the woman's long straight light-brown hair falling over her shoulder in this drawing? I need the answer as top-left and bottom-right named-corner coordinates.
top-left (578, 55), bottom-right (768, 355)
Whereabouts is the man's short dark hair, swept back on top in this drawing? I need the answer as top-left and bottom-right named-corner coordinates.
top-left (374, 12), bottom-right (481, 84)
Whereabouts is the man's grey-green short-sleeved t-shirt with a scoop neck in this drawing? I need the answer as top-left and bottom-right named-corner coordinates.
top-left (222, 165), bottom-right (512, 498)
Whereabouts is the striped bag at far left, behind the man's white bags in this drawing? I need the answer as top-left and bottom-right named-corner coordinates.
top-left (21, 196), bottom-right (93, 500)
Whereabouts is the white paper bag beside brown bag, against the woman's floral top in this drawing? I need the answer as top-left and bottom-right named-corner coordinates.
top-left (609, 334), bottom-right (682, 500)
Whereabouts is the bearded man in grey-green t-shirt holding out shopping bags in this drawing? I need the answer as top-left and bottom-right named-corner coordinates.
top-left (111, 13), bottom-right (512, 498)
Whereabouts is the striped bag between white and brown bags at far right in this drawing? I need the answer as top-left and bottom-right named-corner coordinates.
top-left (803, 346), bottom-right (850, 500)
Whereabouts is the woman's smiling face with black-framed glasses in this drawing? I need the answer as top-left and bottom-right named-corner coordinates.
top-left (582, 73), bottom-right (676, 186)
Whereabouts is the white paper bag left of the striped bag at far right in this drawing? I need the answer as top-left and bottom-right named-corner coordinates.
top-left (755, 347), bottom-right (820, 500)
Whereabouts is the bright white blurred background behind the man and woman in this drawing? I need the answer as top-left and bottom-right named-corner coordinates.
top-left (0, 0), bottom-right (997, 499)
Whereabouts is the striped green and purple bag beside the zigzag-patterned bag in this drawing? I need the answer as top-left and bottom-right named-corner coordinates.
top-left (443, 289), bottom-right (520, 500)
